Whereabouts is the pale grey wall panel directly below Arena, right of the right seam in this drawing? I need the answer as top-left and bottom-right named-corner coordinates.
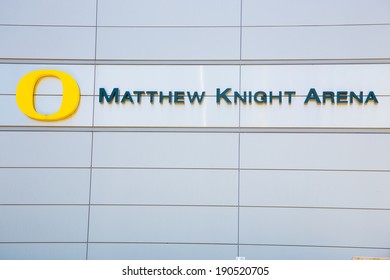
top-left (240, 133), bottom-right (390, 171)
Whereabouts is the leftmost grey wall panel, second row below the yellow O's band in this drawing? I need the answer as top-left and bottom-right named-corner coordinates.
top-left (0, 168), bottom-right (90, 204)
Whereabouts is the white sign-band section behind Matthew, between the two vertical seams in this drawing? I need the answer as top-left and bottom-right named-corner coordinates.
top-left (95, 65), bottom-right (239, 127)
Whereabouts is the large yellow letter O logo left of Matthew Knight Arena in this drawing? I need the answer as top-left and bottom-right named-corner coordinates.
top-left (16, 70), bottom-right (80, 121)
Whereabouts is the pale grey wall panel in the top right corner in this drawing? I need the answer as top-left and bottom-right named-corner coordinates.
top-left (242, 0), bottom-right (390, 26)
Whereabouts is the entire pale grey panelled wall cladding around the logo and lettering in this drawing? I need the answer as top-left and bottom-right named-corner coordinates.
top-left (0, 0), bottom-right (390, 259)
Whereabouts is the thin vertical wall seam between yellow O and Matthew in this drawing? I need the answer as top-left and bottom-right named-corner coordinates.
top-left (85, 0), bottom-right (99, 260)
